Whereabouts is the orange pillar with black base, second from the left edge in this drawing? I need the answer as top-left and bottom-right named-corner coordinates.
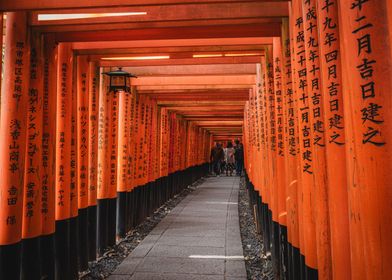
top-left (21, 31), bottom-right (43, 279)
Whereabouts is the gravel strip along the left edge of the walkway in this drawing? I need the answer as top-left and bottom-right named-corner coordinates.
top-left (80, 179), bottom-right (204, 280)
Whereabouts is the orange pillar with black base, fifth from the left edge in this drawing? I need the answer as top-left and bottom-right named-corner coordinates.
top-left (76, 56), bottom-right (90, 271)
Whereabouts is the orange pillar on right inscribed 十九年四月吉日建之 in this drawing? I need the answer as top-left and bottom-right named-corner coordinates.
top-left (317, 0), bottom-right (351, 279)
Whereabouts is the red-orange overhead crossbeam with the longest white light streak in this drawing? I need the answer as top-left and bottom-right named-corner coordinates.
top-left (31, 2), bottom-right (288, 25)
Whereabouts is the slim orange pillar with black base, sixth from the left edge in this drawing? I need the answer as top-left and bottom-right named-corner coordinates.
top-left (87, 62), bottom-right (100, 261)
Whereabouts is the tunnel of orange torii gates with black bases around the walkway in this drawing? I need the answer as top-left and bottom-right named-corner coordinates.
top-left (0, 0), bottom-right (392, 280)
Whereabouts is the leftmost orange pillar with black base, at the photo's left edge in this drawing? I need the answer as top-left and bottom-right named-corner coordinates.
top-left (0, 10), bottom-right (29, 279)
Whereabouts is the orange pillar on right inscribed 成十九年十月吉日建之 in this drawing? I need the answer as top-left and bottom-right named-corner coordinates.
top-left (302, 0), bottom-right (332, 279)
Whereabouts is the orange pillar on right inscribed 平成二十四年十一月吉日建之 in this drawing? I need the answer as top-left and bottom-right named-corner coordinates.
top-left (292, 0), bottom-right (317, 279)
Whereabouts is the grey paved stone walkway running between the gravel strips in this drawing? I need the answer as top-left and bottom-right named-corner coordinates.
top-left (109, 177), bottom-right (246, 280)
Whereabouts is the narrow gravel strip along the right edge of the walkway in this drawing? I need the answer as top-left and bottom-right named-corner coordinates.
top-left (238, 178), bottom-right (275, 280)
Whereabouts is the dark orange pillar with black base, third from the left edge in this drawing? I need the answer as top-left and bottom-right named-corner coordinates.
top-left (41, 36), bottom-right (58, 279)
